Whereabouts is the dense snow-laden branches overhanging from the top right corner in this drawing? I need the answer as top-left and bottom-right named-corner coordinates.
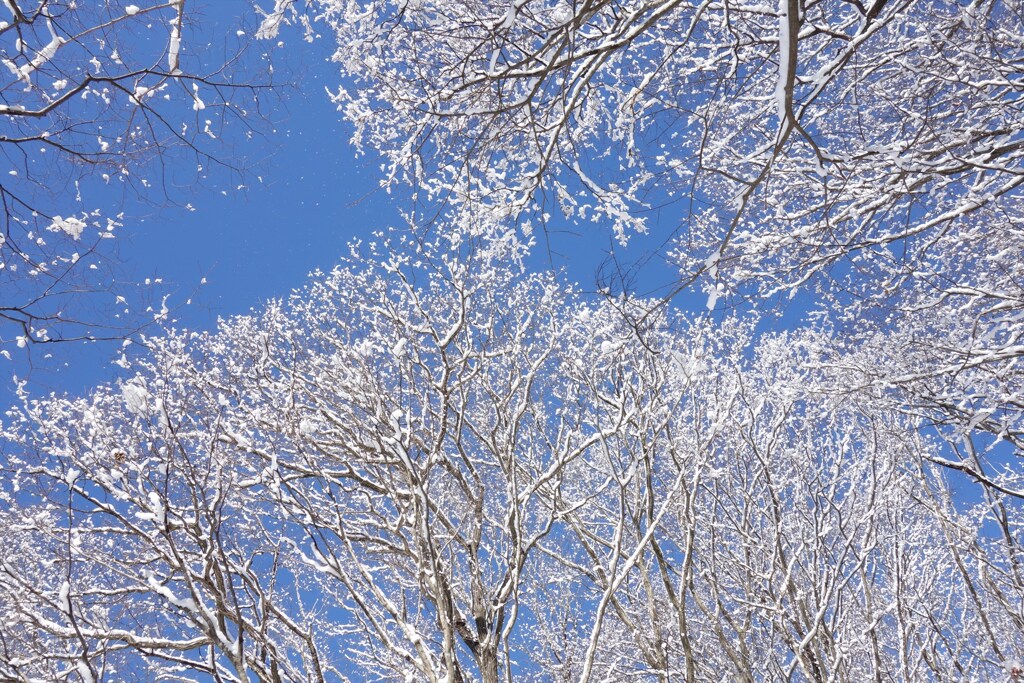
top-left (305, 0), bottom-right (1024, 501)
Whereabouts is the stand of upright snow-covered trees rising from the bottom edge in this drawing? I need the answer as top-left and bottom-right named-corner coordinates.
top-left (0, 231), bottom-right (1024, 683)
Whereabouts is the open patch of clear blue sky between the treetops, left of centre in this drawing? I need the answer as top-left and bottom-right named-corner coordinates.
top-left (0, 7), bottom-right (378, 402)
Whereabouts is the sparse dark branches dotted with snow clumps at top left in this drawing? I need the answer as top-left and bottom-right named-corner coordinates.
top-left (0, 0), bottom-right (271, 345)
